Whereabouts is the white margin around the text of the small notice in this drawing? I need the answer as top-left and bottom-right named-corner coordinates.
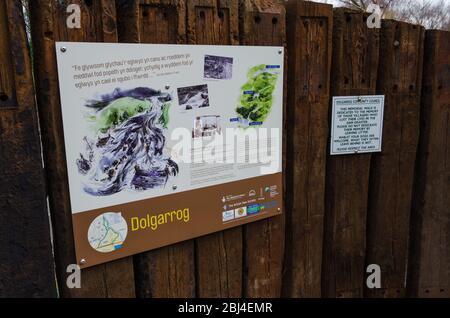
top-left (330, 95), bottom-right (385, 156)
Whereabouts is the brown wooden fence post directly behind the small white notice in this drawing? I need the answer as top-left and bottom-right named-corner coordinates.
top-left (322, 8), bottom-right (379, 297)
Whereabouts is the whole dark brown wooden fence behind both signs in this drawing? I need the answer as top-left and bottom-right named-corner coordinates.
top-left (0, 0), bottom-right (450, 297)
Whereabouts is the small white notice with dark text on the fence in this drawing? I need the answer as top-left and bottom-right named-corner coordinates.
top-left (330, 95), bottom-right (384, 155)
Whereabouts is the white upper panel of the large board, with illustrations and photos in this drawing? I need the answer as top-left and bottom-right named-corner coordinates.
top-left (56, 42), bottom-right (284, 213)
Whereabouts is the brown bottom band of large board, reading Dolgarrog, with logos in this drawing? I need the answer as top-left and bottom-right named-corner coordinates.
top-left (72, 172), bottom-right (282, 268)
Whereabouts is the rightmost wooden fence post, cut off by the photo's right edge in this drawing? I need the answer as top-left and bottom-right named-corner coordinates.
top-left (407, 31), bottom-right (450, 297)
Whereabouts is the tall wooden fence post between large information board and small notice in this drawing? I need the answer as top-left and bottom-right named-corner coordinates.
top-left (283, 0), bottom-right (333, 297)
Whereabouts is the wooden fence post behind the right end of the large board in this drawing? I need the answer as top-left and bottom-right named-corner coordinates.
top-left (239, 0), bottom-right (286, 297)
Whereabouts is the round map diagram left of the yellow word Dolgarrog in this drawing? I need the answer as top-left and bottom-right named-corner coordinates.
top-left (88, 212), bottom-right (128, 253)
